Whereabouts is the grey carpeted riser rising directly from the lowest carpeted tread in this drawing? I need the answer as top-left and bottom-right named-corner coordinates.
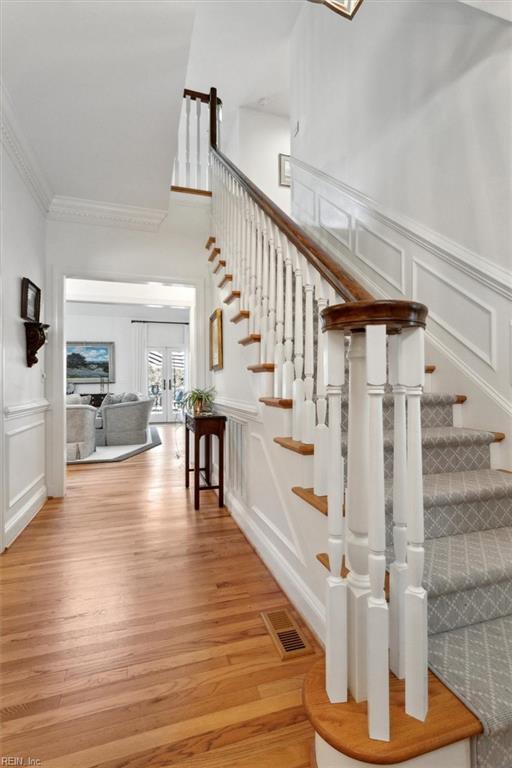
top-left (428, 580), bottom-right (512, 635)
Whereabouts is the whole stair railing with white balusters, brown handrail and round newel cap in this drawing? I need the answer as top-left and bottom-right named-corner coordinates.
top-left (176, 88), bottom-right (428, 740)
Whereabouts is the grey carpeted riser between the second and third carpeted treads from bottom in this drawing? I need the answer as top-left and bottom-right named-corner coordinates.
top-left (386, 498), bottom-right (512, 546)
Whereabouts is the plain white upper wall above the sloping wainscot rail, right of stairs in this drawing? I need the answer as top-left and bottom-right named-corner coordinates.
top-left (291, 0), bottom-right (512, 268)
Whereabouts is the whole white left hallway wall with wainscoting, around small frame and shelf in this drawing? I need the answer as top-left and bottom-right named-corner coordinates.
top-left (0, 146), bottom-right (48, 548)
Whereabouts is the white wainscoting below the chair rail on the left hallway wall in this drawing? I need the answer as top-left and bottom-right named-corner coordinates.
top-left (3, 401), bottom-right (49, 546)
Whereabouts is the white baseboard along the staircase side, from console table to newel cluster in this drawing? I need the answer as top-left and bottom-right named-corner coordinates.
top-left (226, 491), bottom-right (325, 646)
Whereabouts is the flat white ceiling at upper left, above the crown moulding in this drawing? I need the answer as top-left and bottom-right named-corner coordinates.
top-left (2, 0), bottom-right (196, 210)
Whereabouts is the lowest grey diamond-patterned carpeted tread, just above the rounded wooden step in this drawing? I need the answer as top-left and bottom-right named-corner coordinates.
top-left (429, 616), bottom-right (512, 735)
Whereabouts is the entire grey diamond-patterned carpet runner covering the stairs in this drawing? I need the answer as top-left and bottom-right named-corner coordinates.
top-left (384, 394), bottom-right (512, 768)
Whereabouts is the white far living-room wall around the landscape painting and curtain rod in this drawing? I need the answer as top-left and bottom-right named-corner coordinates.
top-left (65, 301), bottom-right (189, 392)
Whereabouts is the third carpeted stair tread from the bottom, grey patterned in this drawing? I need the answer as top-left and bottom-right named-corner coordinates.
top-left (386, 469), bottom-right (512, 509)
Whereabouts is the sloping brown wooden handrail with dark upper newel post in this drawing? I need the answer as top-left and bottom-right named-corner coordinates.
top-left (204, 88), bottom-right (373, 302)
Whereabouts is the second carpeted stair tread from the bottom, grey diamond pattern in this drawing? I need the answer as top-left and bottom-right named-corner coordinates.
top-left (423, 527), bottom-right (512, 598)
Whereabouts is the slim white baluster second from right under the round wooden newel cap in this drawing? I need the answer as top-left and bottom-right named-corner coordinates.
top-left (389, 333), bottom-right (407, 679)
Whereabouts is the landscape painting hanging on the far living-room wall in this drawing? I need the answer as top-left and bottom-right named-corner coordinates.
top-left (66, 341), bottom-right (115, 384)
